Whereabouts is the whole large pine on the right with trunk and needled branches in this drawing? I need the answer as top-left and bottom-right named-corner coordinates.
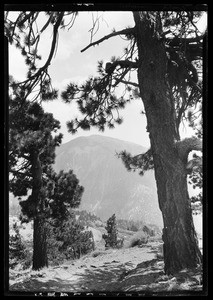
top-left (61, 10), bottom-right (206, 274)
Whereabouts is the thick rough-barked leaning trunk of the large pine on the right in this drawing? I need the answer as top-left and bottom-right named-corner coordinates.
top-left (134, 12), bottom-right (201, 274)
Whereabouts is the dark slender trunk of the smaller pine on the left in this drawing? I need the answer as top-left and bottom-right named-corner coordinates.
top-left (31, 151), bottom-right (48, 270)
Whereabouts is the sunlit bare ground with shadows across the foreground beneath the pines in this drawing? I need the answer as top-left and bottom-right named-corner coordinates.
top-left (10, 242), bottom-right (202, 292)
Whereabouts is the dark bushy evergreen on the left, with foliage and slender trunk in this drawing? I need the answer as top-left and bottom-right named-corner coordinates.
top-left (9, 93), bottom-right (83, 269)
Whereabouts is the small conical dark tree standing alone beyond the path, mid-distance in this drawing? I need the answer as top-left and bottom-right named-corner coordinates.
top-left (102, 214), bottom-right (118, 248)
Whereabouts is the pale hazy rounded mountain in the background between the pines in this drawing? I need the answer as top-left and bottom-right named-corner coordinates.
top-left (54, 135), bottom-right (162, 226)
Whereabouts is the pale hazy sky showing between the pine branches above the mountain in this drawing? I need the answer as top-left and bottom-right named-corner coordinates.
top-left (9, 11), bottom-right (206, 147)
